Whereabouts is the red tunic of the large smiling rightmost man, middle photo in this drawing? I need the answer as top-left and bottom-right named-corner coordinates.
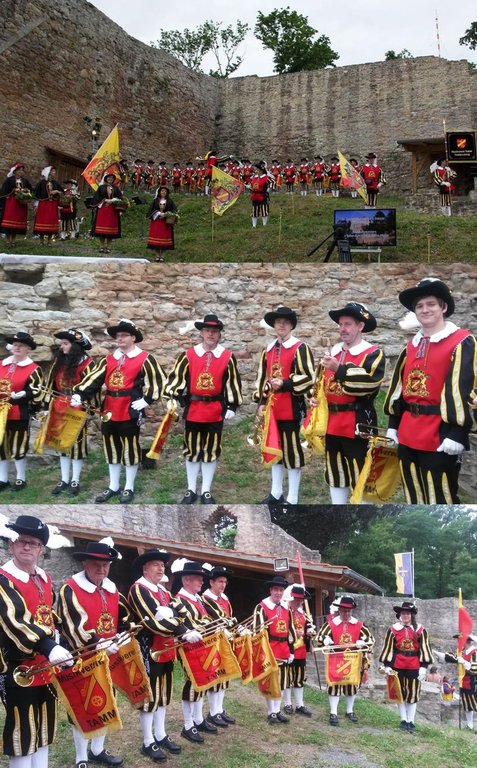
top-left (398, 328), bottom-right (470, 451)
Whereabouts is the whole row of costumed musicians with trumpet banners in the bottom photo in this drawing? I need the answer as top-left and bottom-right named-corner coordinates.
top-left (0, 515), bottom-right (477, 768)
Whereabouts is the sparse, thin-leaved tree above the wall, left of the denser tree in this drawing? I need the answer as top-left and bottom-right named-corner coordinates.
top-left (151, 21), bottom-right (250, 77)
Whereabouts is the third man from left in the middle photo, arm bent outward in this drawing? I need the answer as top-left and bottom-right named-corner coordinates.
top-left (71, 319), bottom-right (166, 504)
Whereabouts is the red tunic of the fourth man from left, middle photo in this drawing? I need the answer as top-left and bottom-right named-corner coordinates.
top-left (186, 347), bottom-right (232, 423)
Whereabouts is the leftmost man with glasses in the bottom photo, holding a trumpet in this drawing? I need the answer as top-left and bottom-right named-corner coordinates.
top-left (0, 515), bottom-right (72, 768)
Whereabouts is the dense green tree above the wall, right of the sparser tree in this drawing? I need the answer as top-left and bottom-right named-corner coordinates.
top-left (255, 6), bottom-right (339, 75)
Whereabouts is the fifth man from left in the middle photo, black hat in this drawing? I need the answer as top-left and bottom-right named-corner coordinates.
top-left (253, 307), bottom-right (314, 505)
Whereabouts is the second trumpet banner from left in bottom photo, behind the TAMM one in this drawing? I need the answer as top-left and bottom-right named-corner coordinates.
top-left (109, 637), bottom-right (153, 709)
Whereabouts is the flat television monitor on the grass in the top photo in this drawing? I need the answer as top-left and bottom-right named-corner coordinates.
top-left (333, 208), bottom-right (397, 248)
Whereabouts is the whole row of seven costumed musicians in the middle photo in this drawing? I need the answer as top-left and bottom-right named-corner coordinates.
top-left (0, 278), bottom-right (477, 505)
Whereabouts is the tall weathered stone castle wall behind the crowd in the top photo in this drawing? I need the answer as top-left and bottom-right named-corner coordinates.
top-left (0, 0), bottom-right (477, 192)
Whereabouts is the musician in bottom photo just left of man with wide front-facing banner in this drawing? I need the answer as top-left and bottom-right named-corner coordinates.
top-left (283, 584), bottom-right (316, 717)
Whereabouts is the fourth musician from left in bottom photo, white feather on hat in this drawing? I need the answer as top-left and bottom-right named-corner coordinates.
top-left (171, 558), bottom-right (218, 744)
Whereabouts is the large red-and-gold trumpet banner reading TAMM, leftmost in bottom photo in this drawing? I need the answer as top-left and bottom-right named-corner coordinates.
top-left (51, 651), bottom-right (123, 736)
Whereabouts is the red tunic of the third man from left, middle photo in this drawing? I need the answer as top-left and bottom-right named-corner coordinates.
top-left (103, 350), bottom-right (148, 421)
